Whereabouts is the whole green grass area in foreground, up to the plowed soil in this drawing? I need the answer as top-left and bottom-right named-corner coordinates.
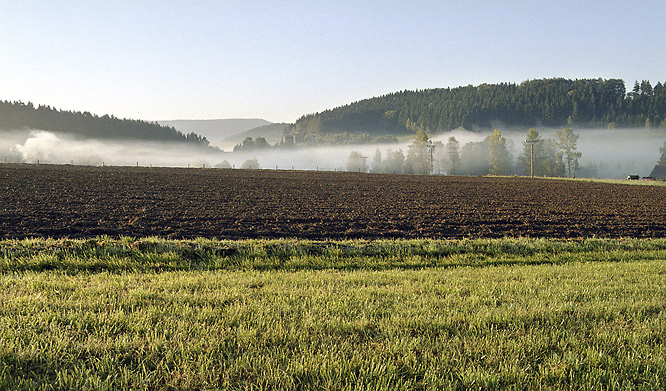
top-left (0, 237), bottom-right (666, 390)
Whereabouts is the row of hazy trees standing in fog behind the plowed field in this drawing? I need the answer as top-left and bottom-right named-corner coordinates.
top-left (347, 128), bottom-right (588, 177)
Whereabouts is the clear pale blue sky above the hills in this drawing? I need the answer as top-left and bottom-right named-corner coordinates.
top-left (0, 0), bottom-right (666, 122)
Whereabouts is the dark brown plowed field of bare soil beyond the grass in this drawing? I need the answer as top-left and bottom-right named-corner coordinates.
top-left (0, 165), bottom-right (666, 239)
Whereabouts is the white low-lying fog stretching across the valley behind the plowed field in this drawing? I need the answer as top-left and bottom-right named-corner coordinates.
top-left (0, 128), bottom-right (666, 178)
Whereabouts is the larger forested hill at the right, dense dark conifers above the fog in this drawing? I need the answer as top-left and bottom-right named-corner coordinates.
top-left (287, 78), bottom-right (666, 137)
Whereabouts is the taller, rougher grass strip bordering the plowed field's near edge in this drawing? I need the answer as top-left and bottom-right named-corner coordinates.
top-left (0, 237), bottom-right (666, 274)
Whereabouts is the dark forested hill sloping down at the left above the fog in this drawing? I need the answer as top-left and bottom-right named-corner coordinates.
top-left (0, 101), bottom-right (208, 146)
